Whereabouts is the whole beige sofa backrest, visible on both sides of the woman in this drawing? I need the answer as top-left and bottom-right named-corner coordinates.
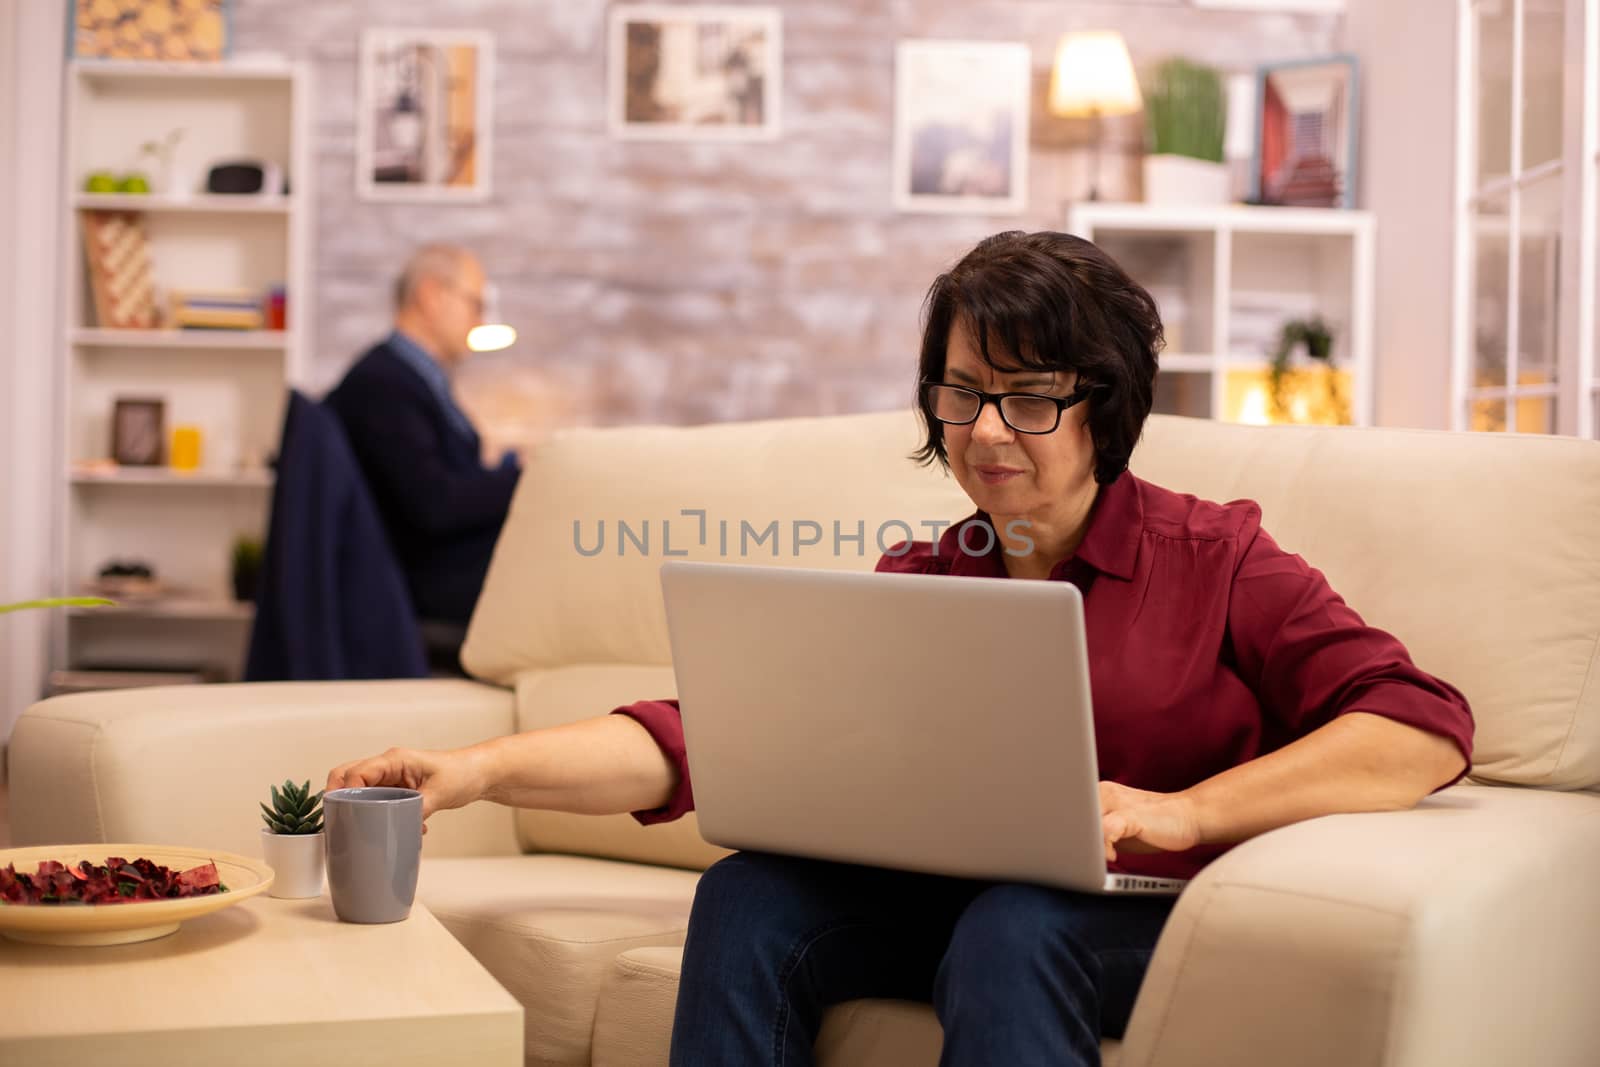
top-left (462, 413), bottom-right (1600, 865)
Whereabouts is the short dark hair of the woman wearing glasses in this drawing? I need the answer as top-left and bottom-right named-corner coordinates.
top-left (915, 230), bottom-right (1165, 485)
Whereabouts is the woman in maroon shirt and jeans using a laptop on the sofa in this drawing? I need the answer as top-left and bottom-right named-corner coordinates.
top-left (328, 232), bottom-right (1472, 1067)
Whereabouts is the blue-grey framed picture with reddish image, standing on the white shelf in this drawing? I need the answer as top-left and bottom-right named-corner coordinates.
top-left (1251, 56), bottom-right (1357, 208)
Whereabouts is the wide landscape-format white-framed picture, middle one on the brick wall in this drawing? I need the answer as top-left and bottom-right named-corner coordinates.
top-left (606, 3), bottom-right (782, 141)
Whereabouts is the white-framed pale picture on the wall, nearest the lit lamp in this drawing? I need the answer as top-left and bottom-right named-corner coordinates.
top-left (893, 40), bottom-right (1032, 214)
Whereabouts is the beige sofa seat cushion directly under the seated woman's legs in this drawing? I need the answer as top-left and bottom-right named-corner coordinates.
top-left (594, 947), bottom-right (1122, 1067)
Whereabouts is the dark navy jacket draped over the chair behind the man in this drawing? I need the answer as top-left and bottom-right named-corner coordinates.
top-left (245, 392), bottom-right (427, 681)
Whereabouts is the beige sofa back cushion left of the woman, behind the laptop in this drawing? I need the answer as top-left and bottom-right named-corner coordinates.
top-left (461, 411), bottom-right (971, 867)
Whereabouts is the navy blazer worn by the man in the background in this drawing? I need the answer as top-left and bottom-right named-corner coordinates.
top-left (325, 344), bottom-right (520, 625)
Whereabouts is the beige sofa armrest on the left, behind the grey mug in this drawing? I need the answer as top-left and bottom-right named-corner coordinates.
top-left (8, 680), bottom-right (517, 856)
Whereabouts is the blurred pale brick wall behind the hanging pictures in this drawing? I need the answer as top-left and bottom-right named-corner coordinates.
top-left (234, 0), bottom-right (1342, 443)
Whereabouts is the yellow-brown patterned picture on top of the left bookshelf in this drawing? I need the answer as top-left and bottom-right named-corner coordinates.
top-left (67, 0), bottom-right (232, 62)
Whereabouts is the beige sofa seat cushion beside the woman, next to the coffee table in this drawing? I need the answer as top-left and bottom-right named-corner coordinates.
top-left (418, 854), bottom-right (699, 1067)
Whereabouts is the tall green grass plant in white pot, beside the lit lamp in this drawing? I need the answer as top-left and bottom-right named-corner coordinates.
top-left (1144, 58), bottom-right (1229, 205)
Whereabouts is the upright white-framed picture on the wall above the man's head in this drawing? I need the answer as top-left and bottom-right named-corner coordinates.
top-left (355, 29), bottom-right (494, 202)
